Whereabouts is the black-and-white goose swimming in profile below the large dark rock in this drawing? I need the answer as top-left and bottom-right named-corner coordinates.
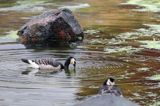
top-left (21, 56), bottom-right (76, 71)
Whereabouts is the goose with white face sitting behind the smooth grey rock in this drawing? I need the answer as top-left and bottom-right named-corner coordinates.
top-left (98, 77), bottom-right (123, 97)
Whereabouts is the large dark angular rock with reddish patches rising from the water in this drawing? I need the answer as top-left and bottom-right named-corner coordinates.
top-left (17, 9), bottom-right (84, 46)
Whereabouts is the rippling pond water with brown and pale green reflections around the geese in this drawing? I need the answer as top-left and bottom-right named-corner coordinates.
top-left (0, 0), bottom-right (160, 106)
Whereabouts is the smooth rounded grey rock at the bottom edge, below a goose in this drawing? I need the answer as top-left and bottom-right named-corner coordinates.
top-left (75, 95), bottom-right (139, 106)
